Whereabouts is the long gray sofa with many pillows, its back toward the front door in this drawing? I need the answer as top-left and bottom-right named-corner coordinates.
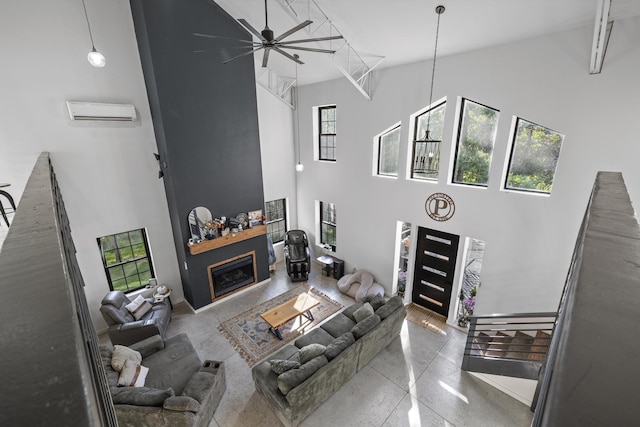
top-left (252, 295), bottom-right (407, 426)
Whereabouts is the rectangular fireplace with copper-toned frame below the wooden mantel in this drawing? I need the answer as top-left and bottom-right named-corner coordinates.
top-left (207, 251), bottom-right (257, 300)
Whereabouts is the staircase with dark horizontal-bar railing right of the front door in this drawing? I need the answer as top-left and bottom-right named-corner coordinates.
top-left (462, 312), bottom-right (557, 380)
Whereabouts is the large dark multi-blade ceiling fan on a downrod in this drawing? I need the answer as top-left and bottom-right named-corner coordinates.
top-left (193, 0), bottom-right (342, 67)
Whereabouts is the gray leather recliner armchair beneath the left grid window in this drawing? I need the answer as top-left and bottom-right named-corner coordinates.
top-left (100, 291), bottom-right (171, 346)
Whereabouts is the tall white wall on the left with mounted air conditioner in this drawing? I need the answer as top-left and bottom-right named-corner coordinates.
top-left (0, 0), bottom-right (183, 330)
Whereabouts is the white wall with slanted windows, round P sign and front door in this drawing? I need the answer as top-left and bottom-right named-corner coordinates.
top-left (298, 18), bottom-right (640, 318)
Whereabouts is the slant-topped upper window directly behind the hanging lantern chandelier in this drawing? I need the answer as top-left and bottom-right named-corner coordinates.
top-left (411, 102), bottom-right (446, 180)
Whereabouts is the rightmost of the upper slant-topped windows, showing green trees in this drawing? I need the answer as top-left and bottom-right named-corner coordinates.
top-left (505, 118), bottom-right (564, 194)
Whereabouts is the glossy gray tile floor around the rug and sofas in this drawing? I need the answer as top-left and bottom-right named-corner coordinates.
top-left (101, 264), bottom-right (533, 427)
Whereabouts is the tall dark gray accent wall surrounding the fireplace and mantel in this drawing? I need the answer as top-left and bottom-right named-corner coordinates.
top-left (130, 0), bottom-right (269, 308)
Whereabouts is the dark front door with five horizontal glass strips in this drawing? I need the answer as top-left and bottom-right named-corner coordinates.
top-left (412, 227), bottom-right (460, 316)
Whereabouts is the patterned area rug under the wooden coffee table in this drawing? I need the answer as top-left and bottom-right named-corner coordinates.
top-left (218, 285), bottom-right (343, 366)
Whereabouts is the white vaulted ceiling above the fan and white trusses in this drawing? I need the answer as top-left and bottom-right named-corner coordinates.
top-left (215, 0), bottom-right (640, 85)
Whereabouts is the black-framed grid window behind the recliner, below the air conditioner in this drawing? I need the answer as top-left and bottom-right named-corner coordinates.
top-left (98, 228), bottom-right (154, 292)
